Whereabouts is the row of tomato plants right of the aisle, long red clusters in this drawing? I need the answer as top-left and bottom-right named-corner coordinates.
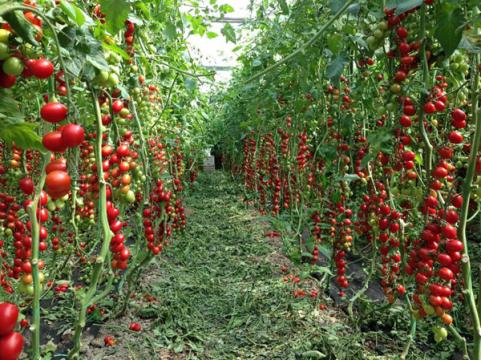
top-left (223, 1), bottom-right (481, 359)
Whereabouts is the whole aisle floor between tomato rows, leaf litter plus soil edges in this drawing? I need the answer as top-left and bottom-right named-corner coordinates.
top-left (79, 172), bottom-right (355, 360)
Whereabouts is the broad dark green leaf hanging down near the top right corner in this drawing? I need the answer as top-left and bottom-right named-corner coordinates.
top-left (434, 2), bottom-right (465, 56)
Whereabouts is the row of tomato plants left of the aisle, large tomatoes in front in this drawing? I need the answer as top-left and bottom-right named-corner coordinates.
top-left (0, 1), bottom-right (204, 360)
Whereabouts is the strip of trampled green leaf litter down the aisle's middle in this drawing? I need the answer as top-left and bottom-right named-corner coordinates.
top-left (146, 173), bottom-right (328, 359)
